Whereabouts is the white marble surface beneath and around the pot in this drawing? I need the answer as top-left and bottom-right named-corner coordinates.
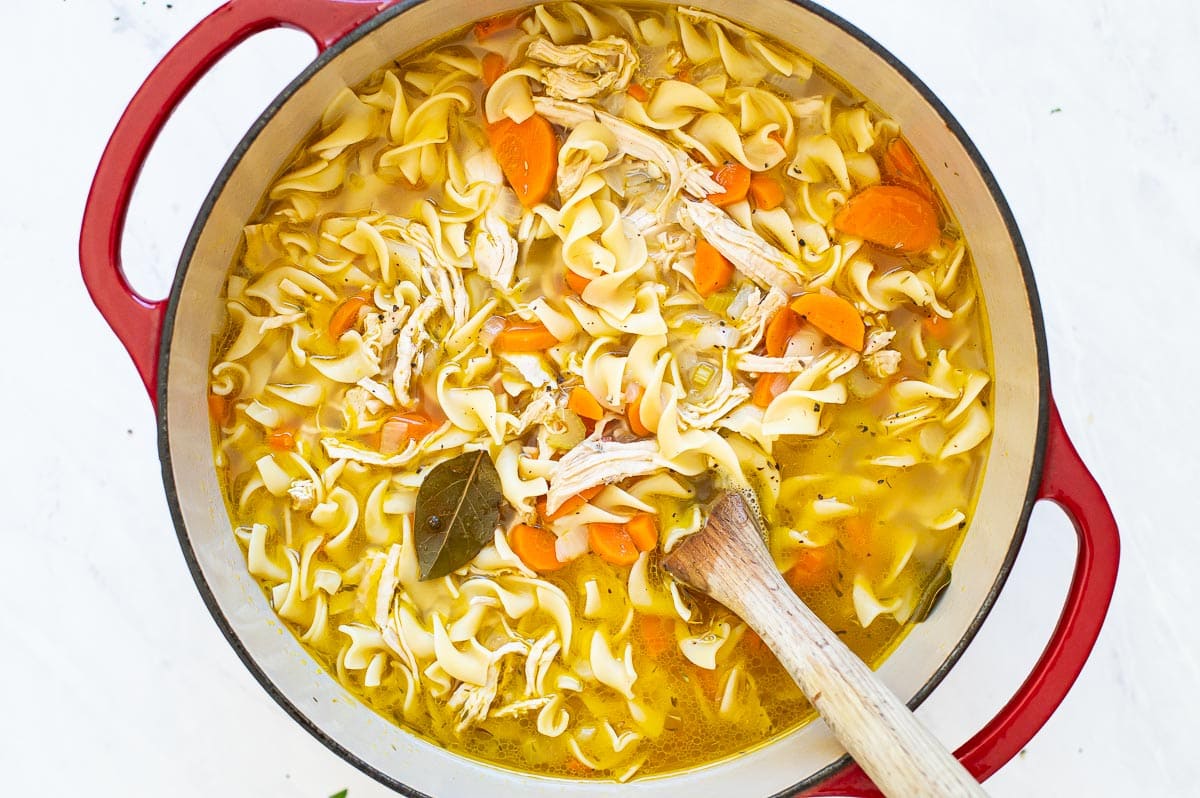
top-left (0, 0), bottom-right (1200, 798)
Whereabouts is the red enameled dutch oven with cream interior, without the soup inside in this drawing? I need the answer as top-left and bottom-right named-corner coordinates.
top-left (79, 0), bottom-right (1118, 796)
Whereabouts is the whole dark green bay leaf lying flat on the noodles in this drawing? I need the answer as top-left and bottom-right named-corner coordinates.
top-left (414, 450), bottom-right (503, 580)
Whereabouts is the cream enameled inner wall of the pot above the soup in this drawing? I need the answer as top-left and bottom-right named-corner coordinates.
top-left (160, 0), bottom-right (1044, 797)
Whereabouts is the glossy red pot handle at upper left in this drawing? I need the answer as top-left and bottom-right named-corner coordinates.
top-left (79, 0), bottom-right (395, 402)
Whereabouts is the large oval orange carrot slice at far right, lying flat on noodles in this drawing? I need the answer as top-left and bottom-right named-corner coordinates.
top-left (833, 186), bottom-right (942, 252)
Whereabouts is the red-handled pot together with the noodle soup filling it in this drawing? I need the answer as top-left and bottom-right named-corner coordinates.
top-left (80, 0), bottom-right (1117, 796)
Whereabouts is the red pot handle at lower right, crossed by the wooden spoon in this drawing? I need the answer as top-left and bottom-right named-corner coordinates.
top-left (805, 397), bottom-right (1121, 798)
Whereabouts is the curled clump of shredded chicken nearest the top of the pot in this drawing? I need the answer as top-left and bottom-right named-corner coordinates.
top-left (526, 36), bottom-right (637, 100)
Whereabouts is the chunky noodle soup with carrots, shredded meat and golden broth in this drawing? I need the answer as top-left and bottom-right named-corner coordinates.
top-left (209, 4), bottom-right (991, 780)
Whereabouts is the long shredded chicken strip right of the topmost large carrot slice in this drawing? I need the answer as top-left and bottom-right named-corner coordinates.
top-left (533, 97), bottom-right (724, 202)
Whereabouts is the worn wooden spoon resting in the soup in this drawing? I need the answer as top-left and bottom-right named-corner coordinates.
top-left (662, 491), bottom-right (986, 798)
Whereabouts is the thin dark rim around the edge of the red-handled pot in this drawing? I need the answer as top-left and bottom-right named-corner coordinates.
top-left (157, 0), bottom-right (1050, 798)
